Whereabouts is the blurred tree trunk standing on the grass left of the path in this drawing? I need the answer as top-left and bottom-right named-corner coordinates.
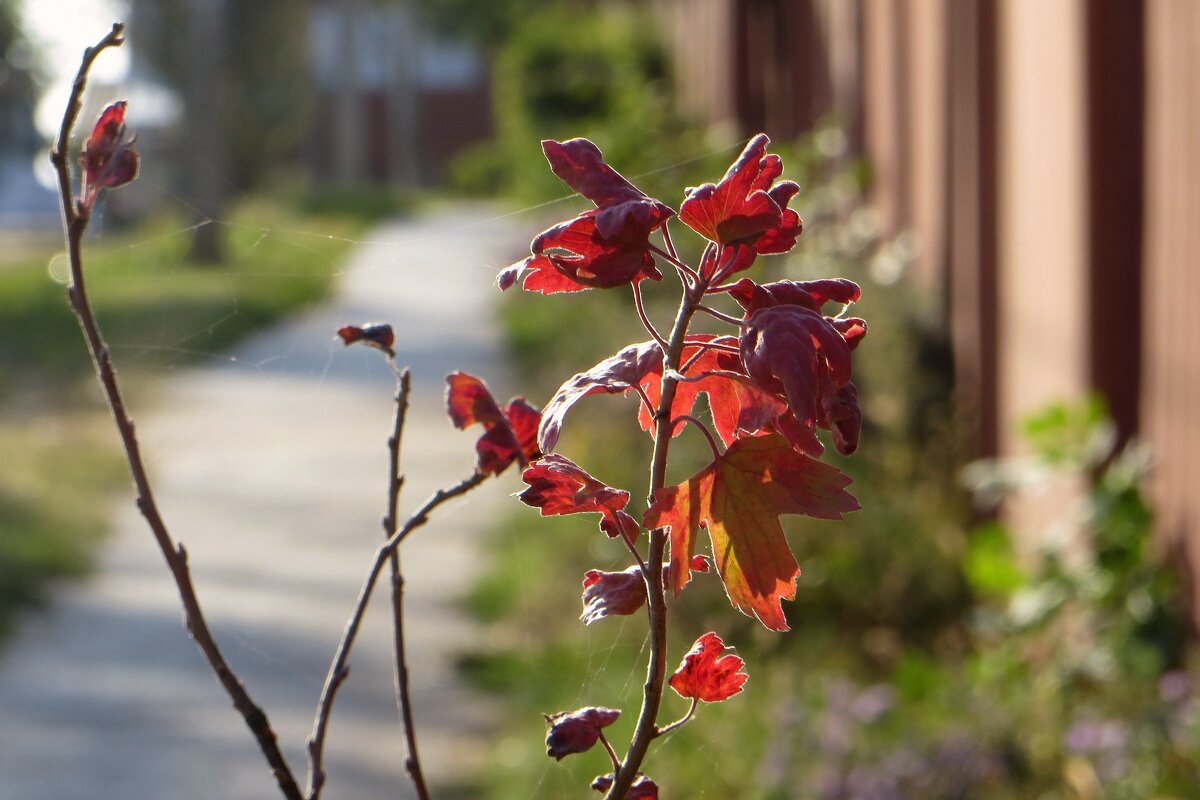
top-left (182, 0), bottom-right (228, 263)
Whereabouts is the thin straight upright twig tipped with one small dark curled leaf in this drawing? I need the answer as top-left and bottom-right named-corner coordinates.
top-left (383, 367), bottom-right (430, 800)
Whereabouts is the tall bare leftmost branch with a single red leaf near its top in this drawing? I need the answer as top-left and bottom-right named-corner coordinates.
top-left (50, 23), bottom-right (304, 800)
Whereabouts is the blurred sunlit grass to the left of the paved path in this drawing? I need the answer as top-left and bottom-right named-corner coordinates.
top-left (0, 200), bottom-right (361, 634)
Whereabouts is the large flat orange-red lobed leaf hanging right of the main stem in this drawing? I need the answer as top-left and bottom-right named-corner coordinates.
top-left (642, 434), bottom-right (858, 631)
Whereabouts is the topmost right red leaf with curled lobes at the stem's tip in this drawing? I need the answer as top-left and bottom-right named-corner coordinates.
top-left (679, 133), bottom-right (802, 268)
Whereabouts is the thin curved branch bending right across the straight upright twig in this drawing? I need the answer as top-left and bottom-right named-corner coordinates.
top-left (306, 473), bottom-right (487, 800)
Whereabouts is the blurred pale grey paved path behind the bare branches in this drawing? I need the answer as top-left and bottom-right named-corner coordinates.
top-left (0, 209), bottom-right (521, 800)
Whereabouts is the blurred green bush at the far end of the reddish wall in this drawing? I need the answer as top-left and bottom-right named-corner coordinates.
top-left (454, 4), bottom-right (708, 201)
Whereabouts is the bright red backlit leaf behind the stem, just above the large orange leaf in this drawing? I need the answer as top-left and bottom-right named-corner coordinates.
top-left (637, 333), bottom-right (787, 445)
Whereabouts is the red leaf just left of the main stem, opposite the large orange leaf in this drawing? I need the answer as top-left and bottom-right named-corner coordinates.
top-left (517, 453), bottom-right (638, 540)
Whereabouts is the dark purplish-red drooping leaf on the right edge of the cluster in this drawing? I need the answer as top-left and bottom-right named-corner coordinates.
top-left (739, 305), bottom-right (865, 456)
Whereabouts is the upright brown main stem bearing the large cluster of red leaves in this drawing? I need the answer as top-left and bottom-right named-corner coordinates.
top-left (605, 273), bottom-right (706, 800)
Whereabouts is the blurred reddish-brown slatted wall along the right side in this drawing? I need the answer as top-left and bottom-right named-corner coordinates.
top-left (656, 0), bottom-right (1200, 619)
